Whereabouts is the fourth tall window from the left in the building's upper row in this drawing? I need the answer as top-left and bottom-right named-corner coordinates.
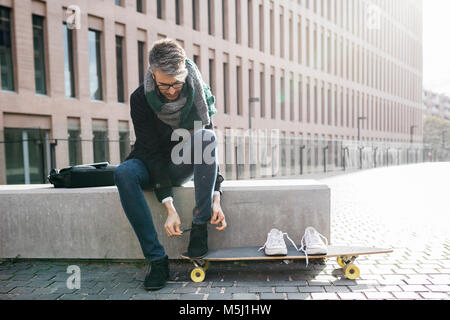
top-left (89, 30), bottom-right (103, 100)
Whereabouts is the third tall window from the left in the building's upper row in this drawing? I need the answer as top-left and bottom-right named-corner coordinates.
top-left (63, 23), bottom-right (76, 98)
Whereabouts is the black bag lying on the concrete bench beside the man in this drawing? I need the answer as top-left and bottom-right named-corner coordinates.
top-left (48, 162), bottom-right (118, 188)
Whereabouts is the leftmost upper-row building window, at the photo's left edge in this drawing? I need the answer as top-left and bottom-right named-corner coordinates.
top-left (0, 7), bottom-right (14, 91)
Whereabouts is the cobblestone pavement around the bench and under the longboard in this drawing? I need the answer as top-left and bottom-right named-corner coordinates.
top-left (0, 163), bottom-right (450, 300)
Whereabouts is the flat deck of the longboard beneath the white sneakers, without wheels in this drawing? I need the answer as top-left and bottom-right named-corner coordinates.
top-left (181, 246), bottom-right (393, 261)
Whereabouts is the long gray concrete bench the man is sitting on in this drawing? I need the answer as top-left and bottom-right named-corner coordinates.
top-left (0, 180), bottom-right (330, 259)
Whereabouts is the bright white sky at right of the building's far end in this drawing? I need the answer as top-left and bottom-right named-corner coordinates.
top-left (423, 0), bottom-right (450, 96)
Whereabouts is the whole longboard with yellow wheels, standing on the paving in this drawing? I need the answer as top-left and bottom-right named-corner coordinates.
top-left (181, 246), bottom-right (393, 282)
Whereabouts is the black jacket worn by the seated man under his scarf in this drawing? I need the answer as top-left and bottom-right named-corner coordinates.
top-left (125, 85), bottom-right (224, 202)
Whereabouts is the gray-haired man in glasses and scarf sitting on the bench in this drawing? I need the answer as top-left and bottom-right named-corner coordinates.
top-left (114, 39), bottom-right (227, 290)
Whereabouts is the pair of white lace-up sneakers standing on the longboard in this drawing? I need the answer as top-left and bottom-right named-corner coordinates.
top-left (258, 227), bottom-right (328, 264)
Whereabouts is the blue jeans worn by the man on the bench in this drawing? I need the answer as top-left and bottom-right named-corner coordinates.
top-left (114, 129), bottom-right (218, 262)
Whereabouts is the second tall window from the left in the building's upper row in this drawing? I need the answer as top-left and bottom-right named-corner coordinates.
top-left (33, 15), bottom-right (47, 94)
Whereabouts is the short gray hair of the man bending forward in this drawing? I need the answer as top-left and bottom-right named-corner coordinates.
top-left (149, 38), bottom-right (188, 81)
